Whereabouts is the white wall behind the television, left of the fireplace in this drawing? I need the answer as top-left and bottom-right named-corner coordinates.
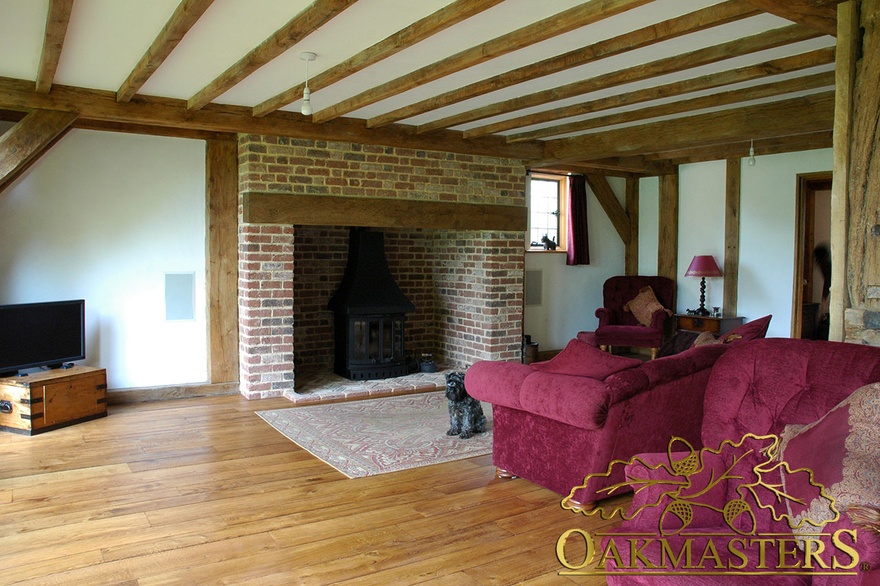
top-left (0, 125), bottom-right (207, 388)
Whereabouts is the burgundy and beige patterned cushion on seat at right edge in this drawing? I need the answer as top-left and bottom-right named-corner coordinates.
top-left (780, 383), bottom-right (880, 529)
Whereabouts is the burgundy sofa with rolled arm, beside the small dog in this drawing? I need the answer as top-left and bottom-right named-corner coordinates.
top-left (465, 334), bottom-right (728, 508)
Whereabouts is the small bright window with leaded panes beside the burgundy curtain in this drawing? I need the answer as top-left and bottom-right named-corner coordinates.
top-left (528, 173), bottom-right (568, 250)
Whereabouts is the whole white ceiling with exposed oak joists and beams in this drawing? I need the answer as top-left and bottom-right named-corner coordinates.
top-left (0, 0), bottom-right (837, 174)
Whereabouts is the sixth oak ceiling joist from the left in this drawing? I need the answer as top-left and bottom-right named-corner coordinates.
top-left (367, 0), bottom-right (760, 128)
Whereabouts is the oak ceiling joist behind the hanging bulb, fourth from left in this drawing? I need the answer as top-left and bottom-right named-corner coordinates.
top-left (253, 0), bottom-right (503, 116)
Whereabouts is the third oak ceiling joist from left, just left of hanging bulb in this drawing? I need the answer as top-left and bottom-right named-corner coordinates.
top-left (187, 0), bottom-right (357, 110)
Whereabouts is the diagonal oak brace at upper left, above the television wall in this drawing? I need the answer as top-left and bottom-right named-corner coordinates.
top-left (0, 110), bottom-right (76, 191)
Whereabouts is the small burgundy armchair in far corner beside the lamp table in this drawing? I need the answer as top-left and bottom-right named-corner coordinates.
top-left (596, 276), bottom-right (675, 359)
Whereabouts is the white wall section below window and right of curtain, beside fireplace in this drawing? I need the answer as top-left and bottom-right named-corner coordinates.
top-left (523, 173), bottom-right (624, 350)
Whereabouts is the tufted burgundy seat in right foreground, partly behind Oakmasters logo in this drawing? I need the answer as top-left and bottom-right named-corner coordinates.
top-left (600, 338), bottom-right (880, 586)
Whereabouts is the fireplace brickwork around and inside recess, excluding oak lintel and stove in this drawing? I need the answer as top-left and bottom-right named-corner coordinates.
top-left (239, 135), bottom-right (525, 398)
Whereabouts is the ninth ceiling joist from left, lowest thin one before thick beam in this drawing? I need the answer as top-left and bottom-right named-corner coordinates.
top-left (510, 71), bottom-right (834, 142)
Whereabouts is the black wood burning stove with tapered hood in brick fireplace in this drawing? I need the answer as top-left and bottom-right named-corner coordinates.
top-left (328, 228), bottom-right (415, 380)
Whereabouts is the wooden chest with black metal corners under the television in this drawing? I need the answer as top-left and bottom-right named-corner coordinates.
top-left (0, 366), bottom-right (107, 435)
